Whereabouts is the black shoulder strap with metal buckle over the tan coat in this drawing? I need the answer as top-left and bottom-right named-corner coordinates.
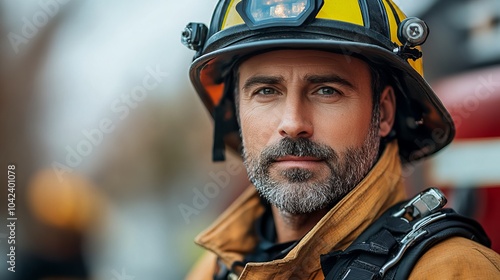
top-left (321, 189), bottom-right (491, 280)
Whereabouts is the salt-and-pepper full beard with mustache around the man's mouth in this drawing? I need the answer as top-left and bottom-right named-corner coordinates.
top-left (243, 114), bottom-right (380, 214)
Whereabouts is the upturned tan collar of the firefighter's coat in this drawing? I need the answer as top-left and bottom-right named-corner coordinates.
top-left (195, 141), bottom-right (406, 279)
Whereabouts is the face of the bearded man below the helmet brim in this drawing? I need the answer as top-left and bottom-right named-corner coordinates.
top-left (238, 50), bottom-right (380, 214)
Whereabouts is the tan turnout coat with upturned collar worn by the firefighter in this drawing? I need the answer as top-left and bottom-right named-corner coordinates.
top-left (187, 143), bottom-right (500, 280)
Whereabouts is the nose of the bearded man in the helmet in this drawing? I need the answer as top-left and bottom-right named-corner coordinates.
top-left (278, 95), bottom-right (313, 138)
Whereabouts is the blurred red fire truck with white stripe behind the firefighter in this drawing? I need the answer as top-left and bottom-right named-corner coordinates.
top-left (425, 65), bottom-right (500, 252)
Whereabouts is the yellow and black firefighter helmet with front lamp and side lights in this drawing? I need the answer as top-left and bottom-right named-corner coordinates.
top-left (182, 0), bottom-right (455, 162)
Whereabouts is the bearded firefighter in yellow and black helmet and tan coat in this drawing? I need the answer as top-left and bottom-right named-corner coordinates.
top-left (182, 0), bottom-right (500, 279)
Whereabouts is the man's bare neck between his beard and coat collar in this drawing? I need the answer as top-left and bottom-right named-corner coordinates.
top-left (272, 206), bottom-right (328, 243)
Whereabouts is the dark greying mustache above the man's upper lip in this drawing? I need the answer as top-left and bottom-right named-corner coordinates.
top-left (260, 137), bottom-right (338, 166)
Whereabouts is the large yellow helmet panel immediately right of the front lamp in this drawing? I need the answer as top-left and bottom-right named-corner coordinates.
top-left (316, 0), bottom-right (364, 26)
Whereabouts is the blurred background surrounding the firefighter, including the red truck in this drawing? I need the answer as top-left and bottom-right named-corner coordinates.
top-left (0, 0), bottom-right (500, 280)
